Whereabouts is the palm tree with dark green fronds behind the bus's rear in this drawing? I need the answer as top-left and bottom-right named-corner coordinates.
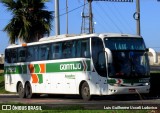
top-left (1, 0), bottom-right (53, 44)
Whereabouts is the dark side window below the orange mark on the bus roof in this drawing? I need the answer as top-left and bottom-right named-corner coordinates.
top-left (18, 48), bottom-right (26, 62)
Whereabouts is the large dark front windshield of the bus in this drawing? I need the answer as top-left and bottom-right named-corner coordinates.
top-left (105, 38), bottom-right (149, 78)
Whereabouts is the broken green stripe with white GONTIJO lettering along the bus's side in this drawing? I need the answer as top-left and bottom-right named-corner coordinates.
top-left (5, 60), bottom-right (91, 74)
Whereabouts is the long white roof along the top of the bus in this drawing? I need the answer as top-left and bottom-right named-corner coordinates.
top-left (7, 33), bottom-right (141, 48)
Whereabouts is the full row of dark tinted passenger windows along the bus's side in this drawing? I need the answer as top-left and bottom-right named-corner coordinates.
top-left (5, 38), bottom-right (90, 63)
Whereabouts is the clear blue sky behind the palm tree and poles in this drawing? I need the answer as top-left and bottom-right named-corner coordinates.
top-left (0, 0), bottom-right (160, 54)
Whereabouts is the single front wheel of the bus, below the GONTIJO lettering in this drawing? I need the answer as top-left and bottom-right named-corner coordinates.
top-left (81, 82), bottom-right (91, 101)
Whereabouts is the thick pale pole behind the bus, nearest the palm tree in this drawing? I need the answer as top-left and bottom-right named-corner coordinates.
top-left (54, 0), bottom-right (60, 35)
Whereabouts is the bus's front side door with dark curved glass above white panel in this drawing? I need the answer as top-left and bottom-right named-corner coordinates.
top-left (91, 37), bottom-right (108, 94)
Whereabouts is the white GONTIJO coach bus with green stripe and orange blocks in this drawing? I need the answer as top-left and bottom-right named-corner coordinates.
top-left (4, 33), bottom-right (150, 100)
